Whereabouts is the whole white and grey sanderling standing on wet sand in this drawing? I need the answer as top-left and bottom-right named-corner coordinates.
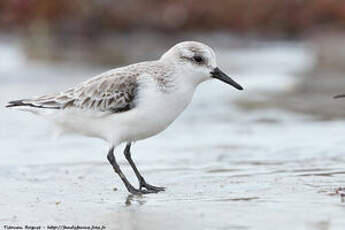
top-left (6, 41), bottom-right (243, 194)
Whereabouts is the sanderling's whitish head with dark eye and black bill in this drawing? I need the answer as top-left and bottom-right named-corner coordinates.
top-left (160, 41), bottom-right (243, 90)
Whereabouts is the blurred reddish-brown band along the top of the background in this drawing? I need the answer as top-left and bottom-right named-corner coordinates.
top-left (0, 0), bottom-right (345, 36)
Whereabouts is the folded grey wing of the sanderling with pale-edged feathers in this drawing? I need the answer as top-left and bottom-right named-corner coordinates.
top-left (9, 70), bottom-right (138, 113)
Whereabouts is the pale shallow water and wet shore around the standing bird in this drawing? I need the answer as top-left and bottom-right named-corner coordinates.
top-left (0, 38), bottom-right (345, 230)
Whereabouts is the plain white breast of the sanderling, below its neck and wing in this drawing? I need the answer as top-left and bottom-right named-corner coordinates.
top-left (113, 76), bottom-right (195, 142)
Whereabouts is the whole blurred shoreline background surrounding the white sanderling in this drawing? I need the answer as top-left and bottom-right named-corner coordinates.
top-left (0, 0), bottom-right (345, 230)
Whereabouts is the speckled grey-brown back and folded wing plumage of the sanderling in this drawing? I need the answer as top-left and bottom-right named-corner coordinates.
top-left (10, 61), bottom-right (174, 112)
